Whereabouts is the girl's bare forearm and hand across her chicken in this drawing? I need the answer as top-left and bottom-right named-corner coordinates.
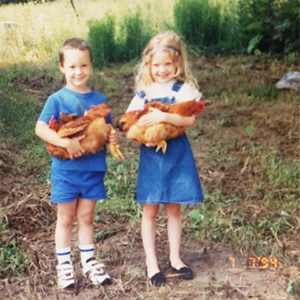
top-left (138, 109), bottom-right (196, 127)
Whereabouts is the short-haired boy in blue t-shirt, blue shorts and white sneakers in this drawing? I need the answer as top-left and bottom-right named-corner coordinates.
top-left (35, 38), bottom-right (118, 288)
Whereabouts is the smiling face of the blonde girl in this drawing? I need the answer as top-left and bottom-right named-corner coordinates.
top-left (151, 50), bottom-right (176, 83)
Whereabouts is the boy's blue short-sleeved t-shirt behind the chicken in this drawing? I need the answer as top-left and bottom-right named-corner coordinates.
top-left (38, 87), bottom-right (111, 172)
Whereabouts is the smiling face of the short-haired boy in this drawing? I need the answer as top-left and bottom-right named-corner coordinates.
top-left (60, 49), bottom-right (92, 93)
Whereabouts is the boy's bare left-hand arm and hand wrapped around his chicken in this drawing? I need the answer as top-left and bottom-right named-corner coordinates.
top-left (35, 121), bottom-right (85, 159)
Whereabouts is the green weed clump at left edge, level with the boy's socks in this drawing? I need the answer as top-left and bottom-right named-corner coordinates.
top-left (0, 219), bottom-right (27, 278)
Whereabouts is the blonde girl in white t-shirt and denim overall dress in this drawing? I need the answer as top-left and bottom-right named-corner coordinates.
top-left (127, 31), bottom-right (204, 286)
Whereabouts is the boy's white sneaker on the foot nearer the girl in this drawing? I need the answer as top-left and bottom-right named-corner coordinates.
top-left (82, 257), bottom-right (111, 285)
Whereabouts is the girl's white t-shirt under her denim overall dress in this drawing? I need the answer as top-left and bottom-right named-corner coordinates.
top-left (127, 79), bottom-right (202, 112)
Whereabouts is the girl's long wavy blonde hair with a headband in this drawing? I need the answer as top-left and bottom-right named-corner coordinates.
top-left (135, 31), bottom-right (199, 90)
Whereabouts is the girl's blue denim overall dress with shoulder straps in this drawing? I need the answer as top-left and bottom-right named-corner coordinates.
top-left (137, 82), bottom-right (204, 204)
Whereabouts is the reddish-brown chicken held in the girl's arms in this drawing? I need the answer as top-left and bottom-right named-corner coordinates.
top-left (117, 100), bottom-right (204, 153)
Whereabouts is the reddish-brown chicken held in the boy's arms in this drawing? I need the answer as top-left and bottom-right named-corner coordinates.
top-left (47, 103), bottom-right (124, 159)
